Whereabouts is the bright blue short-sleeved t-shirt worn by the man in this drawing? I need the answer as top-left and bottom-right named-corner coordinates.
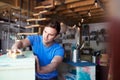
top-left (27, 35), bottom-right (64, 79)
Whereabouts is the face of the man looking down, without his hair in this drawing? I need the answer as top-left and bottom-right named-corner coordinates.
top-left (43, 27), bottom-right (57, 45)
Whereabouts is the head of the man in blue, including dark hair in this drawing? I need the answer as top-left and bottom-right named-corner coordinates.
top-left (43, 21), bottom-right (60, 46)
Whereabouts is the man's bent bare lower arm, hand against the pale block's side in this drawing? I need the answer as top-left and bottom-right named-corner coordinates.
top-left (36, 56), bottom-right (63, 74)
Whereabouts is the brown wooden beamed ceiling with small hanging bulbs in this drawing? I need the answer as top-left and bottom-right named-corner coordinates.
top-left (0, 0), bottom-right (108, 25)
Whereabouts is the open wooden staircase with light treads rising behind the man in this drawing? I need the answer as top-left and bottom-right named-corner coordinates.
top-left (17, 0), bottom-right (54, 35)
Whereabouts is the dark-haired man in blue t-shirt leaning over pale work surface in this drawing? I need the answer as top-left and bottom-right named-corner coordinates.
top-left (12, 22), bottom-right (64, 80)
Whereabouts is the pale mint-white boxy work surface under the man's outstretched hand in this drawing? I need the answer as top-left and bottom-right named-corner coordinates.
top-left (0, 51), bottom-right (35, 80)
